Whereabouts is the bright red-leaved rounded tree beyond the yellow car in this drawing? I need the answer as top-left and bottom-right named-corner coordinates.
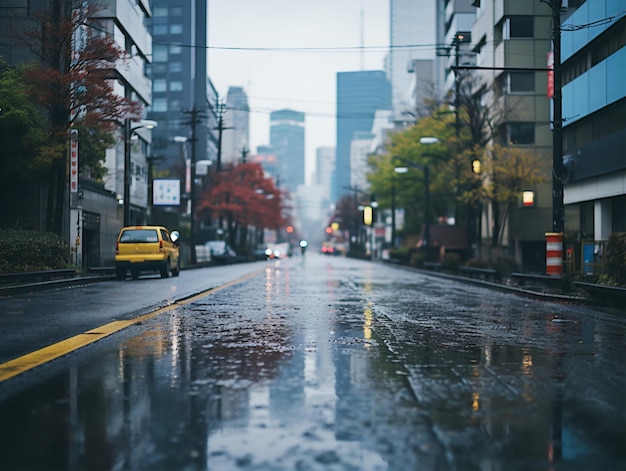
top-left (196, 163), bottom-right (285, 251)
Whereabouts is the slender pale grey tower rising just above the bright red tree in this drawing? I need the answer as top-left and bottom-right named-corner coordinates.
top-left (222, 87), bottom-right (250, 163)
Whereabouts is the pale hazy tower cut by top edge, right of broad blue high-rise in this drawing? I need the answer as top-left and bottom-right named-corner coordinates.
top-left (387, 0), bottom-right (436, 121)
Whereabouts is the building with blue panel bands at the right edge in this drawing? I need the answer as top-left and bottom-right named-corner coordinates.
top-left (561, 0), bottom-right (626, 251)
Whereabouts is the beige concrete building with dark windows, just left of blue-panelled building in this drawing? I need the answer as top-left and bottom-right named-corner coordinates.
top-left (471, 0), bottom-right (552, 272)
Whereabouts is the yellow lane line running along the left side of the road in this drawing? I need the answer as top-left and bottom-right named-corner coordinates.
top-left (0, 269), bottom-right (265, 382)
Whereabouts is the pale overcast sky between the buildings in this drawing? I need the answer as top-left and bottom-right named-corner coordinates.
top-left (208, 0), bottom-right (389, 182)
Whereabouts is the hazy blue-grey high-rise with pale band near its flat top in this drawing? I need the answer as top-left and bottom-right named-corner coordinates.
top-left (270, 109), bottom-right (305, 194)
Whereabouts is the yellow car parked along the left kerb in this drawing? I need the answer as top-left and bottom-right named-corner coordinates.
top-left (115, 226), bottom-right (180, 280)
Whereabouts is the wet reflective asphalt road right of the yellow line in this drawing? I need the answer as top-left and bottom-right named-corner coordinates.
top-left (0, 253), bottom-right (626, 471)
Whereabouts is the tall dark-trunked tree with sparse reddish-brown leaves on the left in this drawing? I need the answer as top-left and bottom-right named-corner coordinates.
top-left (17, 0), bottom-right (141, 234)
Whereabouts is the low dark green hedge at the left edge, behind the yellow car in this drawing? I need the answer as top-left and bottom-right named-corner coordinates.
top-left (0, 229), bottom-right (69, 273)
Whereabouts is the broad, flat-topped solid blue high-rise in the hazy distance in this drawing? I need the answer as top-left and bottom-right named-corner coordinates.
top-left (331, 70), bottom-right (391, 202)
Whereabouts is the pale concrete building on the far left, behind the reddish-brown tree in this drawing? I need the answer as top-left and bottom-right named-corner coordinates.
top-left (0, 0), bottom-right (152, 268)
